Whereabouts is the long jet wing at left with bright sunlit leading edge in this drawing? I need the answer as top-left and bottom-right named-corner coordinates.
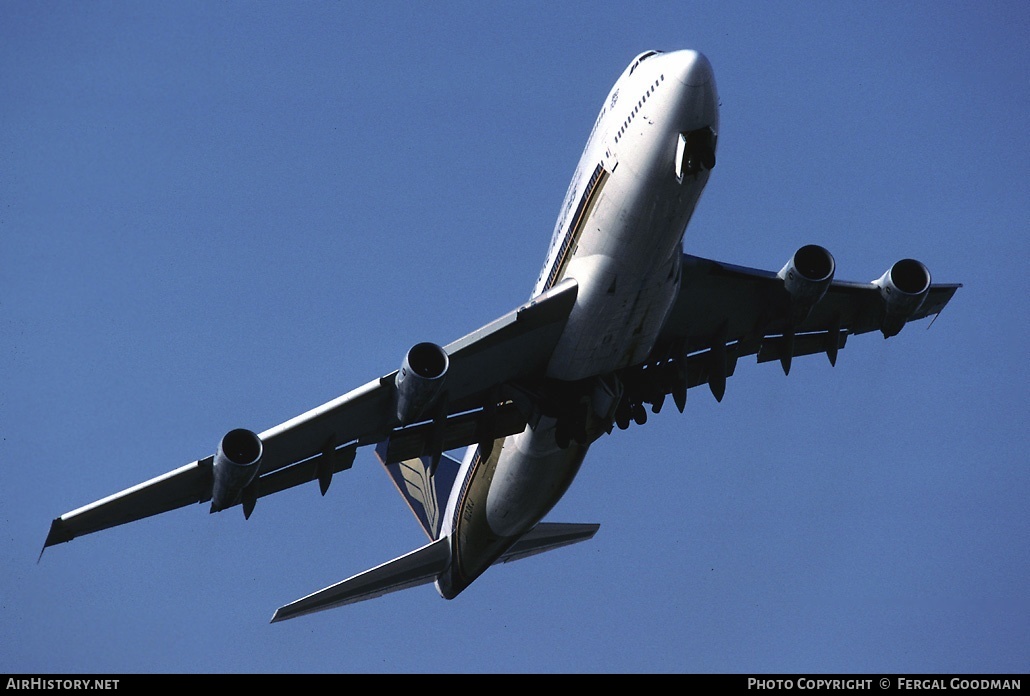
top-left (43, 279), bottom-right (578, 550)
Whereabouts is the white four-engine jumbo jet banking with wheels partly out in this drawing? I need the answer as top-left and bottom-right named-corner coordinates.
top-left (40, 49), bottom-right (961, 622)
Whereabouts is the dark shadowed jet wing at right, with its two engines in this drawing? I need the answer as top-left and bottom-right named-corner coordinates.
top-left (616, 250), bottom-right (961, 413)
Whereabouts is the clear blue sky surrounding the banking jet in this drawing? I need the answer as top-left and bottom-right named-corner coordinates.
top-left (0, 0), bottom-right (1030, 673)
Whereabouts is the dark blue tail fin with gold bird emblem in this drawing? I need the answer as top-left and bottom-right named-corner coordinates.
top-left (376, 440), bottom-right (461, 541)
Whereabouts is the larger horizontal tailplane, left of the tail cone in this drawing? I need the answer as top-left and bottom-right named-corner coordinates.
top-left (272, 537), bottom-right (450, 623)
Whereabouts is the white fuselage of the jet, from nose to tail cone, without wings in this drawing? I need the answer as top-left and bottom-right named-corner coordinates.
top-left (437, 50), bottom-right (719, 598)
